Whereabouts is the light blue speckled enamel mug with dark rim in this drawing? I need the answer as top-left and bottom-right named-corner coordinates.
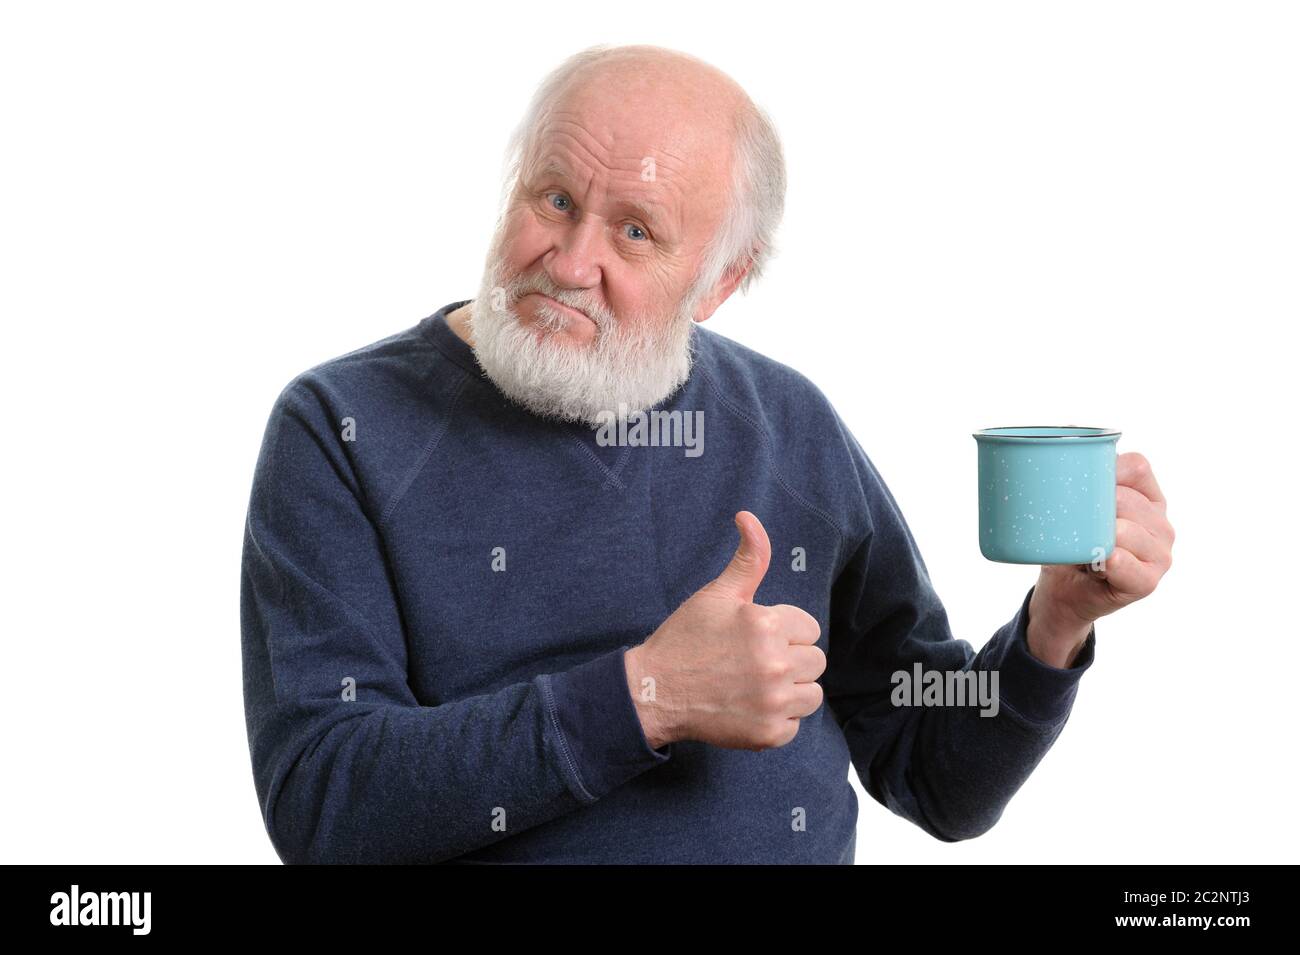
top-left (974, 425), bottom-right (1121, 564)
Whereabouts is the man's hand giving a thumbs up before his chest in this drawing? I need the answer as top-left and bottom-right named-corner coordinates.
top-left (624, 511), bottom-right (826, 750)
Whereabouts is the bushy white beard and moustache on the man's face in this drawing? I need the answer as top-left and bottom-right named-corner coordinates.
top-left (469, 243), bottom-right (699, 427)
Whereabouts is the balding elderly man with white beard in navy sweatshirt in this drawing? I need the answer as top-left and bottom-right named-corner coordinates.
top-left (242, 47), bottom-right (1173, 863)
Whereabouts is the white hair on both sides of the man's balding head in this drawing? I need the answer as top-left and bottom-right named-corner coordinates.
top-left (498, 43), bottom-right (785, 294)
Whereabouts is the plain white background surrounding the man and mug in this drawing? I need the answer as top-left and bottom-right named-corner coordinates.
top-left (0, 0), bottom-right (1300, 863)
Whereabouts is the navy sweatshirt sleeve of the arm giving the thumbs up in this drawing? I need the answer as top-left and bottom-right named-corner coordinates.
top-left (241, 377), bottom-right (672, 863)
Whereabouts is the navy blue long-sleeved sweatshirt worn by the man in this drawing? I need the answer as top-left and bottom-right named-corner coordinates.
top-left (242, 301), bottom-right (1096, 863)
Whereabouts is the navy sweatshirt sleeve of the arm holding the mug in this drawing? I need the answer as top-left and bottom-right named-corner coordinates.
top-left (824, 422), bottom-right (1096, 842)
